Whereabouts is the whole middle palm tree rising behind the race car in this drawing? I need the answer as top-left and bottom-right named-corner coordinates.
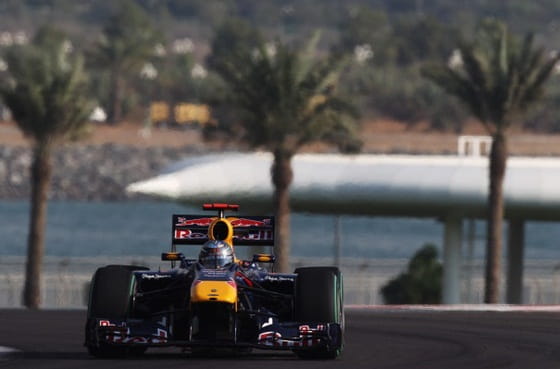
top-left (213, 31), bottom-right (359, 272)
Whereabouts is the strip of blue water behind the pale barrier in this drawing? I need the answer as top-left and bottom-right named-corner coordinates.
top-left (0, 201), bottom-right (560, 262)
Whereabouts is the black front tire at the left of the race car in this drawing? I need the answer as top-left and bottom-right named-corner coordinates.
top-left (86, 265), bottom-right (148, 357)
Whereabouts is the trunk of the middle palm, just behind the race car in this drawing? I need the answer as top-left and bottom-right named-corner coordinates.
top-left (271, 150), bottom-right (293, 273)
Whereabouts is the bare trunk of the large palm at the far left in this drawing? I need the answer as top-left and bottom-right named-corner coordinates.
top-left (23, 143), bottom-right (51, 309)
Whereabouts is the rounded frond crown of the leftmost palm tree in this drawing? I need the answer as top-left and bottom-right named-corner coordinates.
top-left (0, 27), bottom-right (93, 142)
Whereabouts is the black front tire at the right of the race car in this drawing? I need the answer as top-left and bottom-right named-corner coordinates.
top-left (295, 267), bottom-right (344, 359)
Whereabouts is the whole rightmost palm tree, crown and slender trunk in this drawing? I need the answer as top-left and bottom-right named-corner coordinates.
top-left (424, 20), bottom-right (559, 303)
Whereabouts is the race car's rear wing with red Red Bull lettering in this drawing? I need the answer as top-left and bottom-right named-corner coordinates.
top-left (171, 214), bottom-right (274, 246)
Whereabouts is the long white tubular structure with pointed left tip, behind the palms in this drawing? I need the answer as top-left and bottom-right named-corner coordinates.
top-left (128, 153), bottom-right (560, 220)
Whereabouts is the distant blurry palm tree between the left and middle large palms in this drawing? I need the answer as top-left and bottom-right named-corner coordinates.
top-left (90, 0), bottom-right (161, 123)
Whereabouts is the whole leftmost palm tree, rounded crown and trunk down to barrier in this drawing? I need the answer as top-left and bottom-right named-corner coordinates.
top-left (0, 28), bottom-right (92, 308)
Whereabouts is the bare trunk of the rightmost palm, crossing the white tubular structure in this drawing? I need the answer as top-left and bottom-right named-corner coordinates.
top-left (484, 131), bottom-right (507, 304)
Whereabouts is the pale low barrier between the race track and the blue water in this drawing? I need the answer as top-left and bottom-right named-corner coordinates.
top-left (0, 257), bottom-right (560, 308)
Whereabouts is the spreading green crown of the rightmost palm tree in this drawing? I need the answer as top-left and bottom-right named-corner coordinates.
top-left (424, 20), bottom-right (558, 134)
